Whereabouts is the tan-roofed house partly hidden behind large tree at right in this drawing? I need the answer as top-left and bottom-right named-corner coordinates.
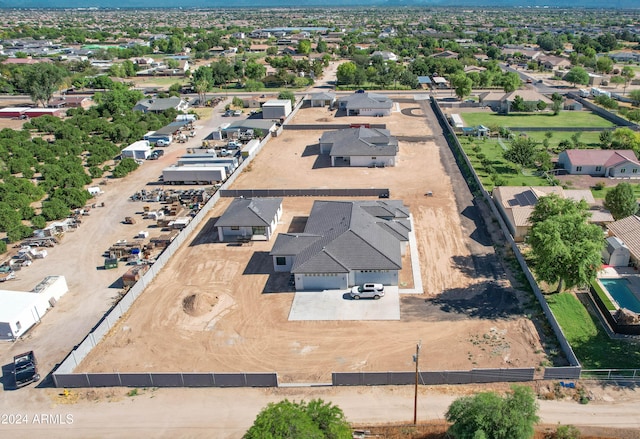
top-left (492, 186), bottom-right (613, 241)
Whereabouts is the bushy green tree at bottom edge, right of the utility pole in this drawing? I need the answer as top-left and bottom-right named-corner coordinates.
top-left (445, 386), bottom-right (539, 439)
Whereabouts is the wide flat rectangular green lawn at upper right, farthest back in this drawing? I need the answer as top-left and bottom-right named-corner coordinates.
top-left (460, 111), bottom-right (613, 128)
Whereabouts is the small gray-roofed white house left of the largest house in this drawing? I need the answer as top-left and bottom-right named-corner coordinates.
top-left (214, 198), bottom-right (282, 242)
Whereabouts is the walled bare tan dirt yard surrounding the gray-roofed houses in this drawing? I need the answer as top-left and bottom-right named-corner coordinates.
top-left (77, 98), bottom-right (546, 382)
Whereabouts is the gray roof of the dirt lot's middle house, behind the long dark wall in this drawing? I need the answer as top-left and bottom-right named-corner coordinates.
top-left (320, 128), bottom-right (398, 157)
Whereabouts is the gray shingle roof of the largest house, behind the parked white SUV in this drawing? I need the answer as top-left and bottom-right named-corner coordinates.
top-left (271, 200), bottom-right (410, 273)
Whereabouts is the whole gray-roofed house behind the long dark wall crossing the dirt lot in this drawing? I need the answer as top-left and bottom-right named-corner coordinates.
top-left (320, 127), bottom-right (398, 167)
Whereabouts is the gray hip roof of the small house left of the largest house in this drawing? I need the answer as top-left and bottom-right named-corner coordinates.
top-left (215, 198), bottom-right (282, 227)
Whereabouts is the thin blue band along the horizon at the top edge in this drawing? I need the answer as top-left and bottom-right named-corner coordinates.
top-left (0, 0), bottom-right (640, 9)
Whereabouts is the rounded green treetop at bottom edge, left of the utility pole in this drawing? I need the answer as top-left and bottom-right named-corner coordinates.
top-left (244, 399), bottom-right (351, 439)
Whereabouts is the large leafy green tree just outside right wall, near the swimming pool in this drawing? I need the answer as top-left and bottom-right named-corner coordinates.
top-left (527, 194), bottom-right (604, 292)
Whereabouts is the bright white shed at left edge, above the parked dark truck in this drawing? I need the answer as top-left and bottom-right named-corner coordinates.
top-left (0, 276), bottom-right (69, 340)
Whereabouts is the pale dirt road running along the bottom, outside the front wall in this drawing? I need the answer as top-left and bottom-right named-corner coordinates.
top-left (0, 386), bottom-right (640, 439)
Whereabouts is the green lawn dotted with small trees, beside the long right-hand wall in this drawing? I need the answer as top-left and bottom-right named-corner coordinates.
top-left (460, 137), bottom-right (550, 192)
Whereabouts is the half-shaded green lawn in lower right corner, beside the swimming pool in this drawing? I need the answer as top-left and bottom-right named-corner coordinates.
top-left (547, 293), bottom-right (640, 369)
